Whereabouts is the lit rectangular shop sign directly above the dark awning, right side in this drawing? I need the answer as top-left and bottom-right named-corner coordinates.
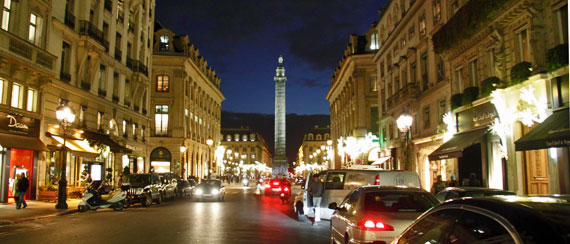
top-left (457, 103), bottom-right (498, 132)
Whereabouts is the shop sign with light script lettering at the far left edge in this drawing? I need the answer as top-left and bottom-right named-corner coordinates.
top-left (0, 112), bottom-right (40, 137)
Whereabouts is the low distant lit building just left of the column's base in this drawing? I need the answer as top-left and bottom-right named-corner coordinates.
top-left (217, 128), bottom-right (272, 176)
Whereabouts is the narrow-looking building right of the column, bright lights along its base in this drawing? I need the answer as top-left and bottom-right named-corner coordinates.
top-left (326, 28), bottom-right (379, 169)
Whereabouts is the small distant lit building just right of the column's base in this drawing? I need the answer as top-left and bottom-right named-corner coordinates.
top-left (295, 126), bottom-right (334, 169)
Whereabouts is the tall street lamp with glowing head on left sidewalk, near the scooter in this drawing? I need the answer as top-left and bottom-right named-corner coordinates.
top-left (55, 104), bottom-right (75, 209)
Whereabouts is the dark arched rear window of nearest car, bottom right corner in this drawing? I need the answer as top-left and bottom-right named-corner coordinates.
top-left (443, 211), bottom-right (515, 243)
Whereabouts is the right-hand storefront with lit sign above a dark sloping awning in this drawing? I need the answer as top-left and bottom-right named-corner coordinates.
top-left (428, 101), bottom-right (505, 189)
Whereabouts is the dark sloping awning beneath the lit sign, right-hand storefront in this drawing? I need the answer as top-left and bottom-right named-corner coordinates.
top-left (429, 127), bottom-right (488, 161)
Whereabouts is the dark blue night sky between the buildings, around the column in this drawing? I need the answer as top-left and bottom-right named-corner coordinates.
top-left (156, 0), bottom-right (386, 114)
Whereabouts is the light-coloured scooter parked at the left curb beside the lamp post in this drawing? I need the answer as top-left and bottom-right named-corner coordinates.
top-left (77, 181), bottom-right (127, 212)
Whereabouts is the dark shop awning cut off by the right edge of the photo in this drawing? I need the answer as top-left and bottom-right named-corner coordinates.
top-left (515, 108), bottom-right (570, 151)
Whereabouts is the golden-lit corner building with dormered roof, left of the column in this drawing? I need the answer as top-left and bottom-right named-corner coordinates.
top-left (149, 23), bottom-right (225, 178)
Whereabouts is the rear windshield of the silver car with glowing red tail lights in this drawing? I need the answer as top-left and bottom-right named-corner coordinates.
top-left (364, 192), bottom-right (435, 212)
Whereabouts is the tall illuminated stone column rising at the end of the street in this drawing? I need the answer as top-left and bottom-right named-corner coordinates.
top-left (272, 56), bottom-right (289, 175)
